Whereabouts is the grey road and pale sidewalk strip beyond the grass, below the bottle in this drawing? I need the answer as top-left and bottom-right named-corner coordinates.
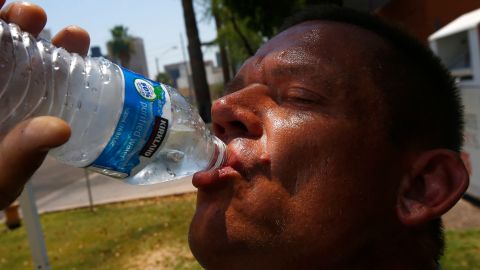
top-left (0, 158), bottom-right (196, 219)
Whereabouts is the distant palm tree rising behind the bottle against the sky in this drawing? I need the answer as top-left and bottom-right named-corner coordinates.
top-left (107, 25), bottom-right (134, 68)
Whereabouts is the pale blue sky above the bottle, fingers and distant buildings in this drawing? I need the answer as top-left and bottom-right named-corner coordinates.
top-left (6, 0), bottom-right (217, 77)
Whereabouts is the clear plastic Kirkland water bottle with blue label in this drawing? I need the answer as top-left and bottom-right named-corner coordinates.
top-left (0, 20), bottom-right (226, 185)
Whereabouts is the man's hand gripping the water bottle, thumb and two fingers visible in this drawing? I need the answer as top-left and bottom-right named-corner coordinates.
top-left (0, 0), bottom-right (90, 209)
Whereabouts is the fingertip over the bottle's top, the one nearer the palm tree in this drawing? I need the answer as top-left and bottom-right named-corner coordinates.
top-left (52, 26), bottom-right (90, 56)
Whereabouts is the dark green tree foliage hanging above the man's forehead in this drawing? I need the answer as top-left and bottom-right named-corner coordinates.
top-left (202, 0), bottom-right (343, 73)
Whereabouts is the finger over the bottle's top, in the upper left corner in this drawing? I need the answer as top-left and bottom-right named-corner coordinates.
top-left (0, 0), bottom-right (47, 37)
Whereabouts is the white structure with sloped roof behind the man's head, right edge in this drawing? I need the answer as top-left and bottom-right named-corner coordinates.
top-left (428, 9), bottom-right (480, 200)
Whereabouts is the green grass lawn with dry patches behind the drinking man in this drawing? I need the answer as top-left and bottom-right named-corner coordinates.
top-left (0, 194), bottom-right (480, 270)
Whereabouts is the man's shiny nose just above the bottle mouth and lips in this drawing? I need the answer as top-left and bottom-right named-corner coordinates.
top-left (212, 86), bottom-right (263, 143)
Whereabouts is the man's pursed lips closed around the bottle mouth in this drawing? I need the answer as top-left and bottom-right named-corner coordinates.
top-left (192, 147), bottom-right (243, 190)
